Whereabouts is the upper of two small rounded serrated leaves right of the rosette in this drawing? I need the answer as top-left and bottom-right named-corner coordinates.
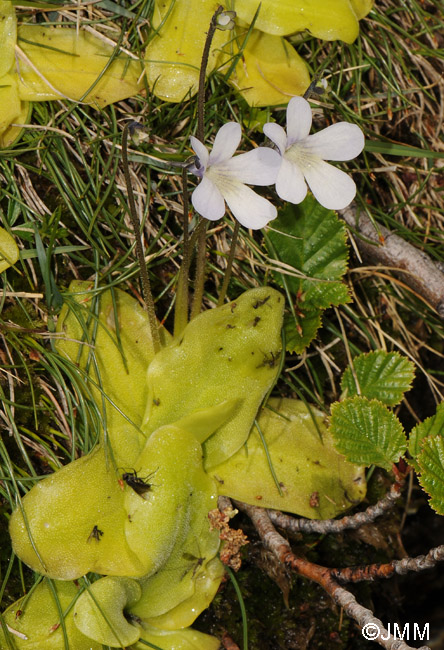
top-left (341, 350), bottom-right (415, 406)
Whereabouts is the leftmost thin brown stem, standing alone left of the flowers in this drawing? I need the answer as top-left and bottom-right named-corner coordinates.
top-left (122, 124), bottom-right (161, 352)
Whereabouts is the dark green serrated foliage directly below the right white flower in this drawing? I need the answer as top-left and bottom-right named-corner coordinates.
top-left (267, 196), bottom-right (350, 352)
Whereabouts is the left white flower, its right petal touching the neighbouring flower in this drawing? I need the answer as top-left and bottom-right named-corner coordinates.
top-left (190, 122), bottom-right (280, 229)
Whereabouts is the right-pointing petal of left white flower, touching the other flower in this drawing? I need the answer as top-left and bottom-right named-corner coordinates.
top-left (224, 147), bottom-right (282, 185)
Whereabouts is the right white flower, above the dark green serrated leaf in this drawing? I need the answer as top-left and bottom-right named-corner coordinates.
top-left (264, 97), bottom-right (364, 210)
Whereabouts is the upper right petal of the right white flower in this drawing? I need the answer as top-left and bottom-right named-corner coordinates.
top-left (301, 122), bottom-right (364, 160)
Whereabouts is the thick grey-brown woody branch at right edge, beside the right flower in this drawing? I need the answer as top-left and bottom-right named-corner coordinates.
top-left (339, 203), bottom-right (444, 319)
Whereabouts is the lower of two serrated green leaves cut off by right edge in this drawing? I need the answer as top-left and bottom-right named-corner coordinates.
top-left (417, 432), bottom-right (444, 515)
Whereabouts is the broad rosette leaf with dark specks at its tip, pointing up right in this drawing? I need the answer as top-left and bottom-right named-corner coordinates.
top-left (142, 287), bottom-right (284, 468)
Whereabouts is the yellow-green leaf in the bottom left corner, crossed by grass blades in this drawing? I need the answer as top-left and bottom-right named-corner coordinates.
top-left (0, 580), bottom-right (102, 650)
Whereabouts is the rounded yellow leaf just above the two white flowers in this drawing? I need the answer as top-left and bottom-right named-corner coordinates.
top-left (220, 29), bottom-right (310, 106)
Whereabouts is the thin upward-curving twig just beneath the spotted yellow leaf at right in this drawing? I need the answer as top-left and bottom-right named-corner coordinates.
top-left (267, 482), bottom-right (403, 534)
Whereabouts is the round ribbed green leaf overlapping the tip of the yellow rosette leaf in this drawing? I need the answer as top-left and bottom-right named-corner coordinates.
top-left (330, 396), bottom-right (406, 470)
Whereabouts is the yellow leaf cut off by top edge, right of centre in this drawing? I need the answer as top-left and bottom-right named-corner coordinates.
top-left (234, 0), bottom-right (359, 43)
